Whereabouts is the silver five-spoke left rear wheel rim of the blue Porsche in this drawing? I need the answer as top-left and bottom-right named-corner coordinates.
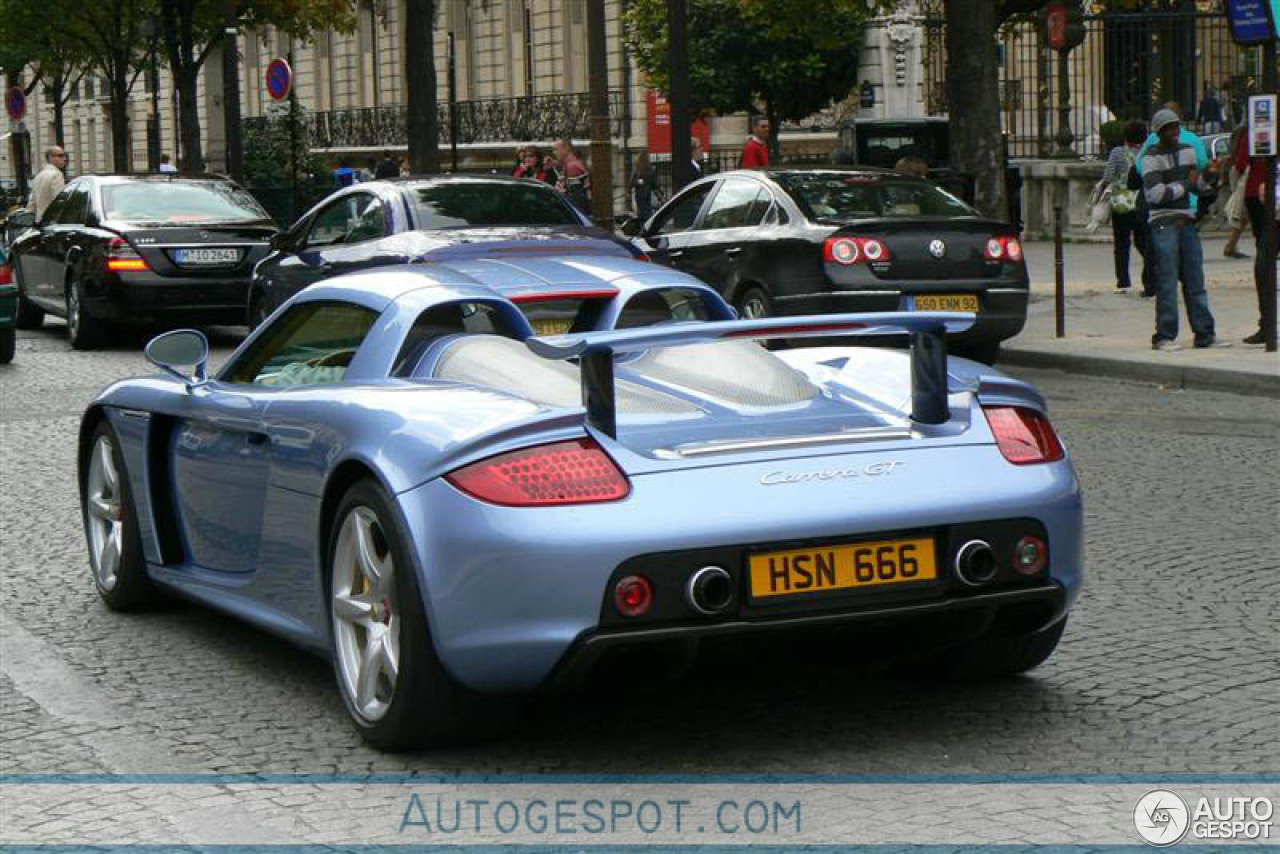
top-left (330, 506), bottom-right (401, 722)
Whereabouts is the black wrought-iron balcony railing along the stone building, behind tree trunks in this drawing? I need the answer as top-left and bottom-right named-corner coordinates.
top-left (244, 90), bottom-right (623, 150)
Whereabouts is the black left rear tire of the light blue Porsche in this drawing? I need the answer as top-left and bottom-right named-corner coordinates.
top-left (324, 480), bottom-right (508, 752)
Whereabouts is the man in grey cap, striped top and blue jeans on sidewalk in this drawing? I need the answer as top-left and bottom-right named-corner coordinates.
top-left (1140, 109), bottom-right (1228, 350)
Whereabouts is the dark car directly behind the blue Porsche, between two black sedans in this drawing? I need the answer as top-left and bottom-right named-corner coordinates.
top-left (248, 175), bottom-right (640, 328)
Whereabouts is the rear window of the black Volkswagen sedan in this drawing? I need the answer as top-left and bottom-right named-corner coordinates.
top-left (778, 173), bottom-right (975, 220)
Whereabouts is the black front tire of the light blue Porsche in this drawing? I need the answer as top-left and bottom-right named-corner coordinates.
top-left (79, 419), bottom-right (161, 611)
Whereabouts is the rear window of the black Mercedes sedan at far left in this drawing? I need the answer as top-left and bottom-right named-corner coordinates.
top-left (102, 181), bottom-right (269, 225)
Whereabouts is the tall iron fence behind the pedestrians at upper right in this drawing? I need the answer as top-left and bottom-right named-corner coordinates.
top-left (923, 12), bottom-right (1262, 157)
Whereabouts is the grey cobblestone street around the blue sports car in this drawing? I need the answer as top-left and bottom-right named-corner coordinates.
top-left (0, 321), bottom-right (1280, 773)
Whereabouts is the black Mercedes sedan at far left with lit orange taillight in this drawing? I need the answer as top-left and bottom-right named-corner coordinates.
top-left (12, 175), bottom-right (276, 350)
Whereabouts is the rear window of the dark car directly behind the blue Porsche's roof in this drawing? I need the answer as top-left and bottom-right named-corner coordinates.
top-left (410, 181), bottom-right (582, 228)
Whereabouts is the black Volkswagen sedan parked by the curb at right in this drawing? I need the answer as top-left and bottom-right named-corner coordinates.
top-left (622, 168), bottom-right (1028, 362)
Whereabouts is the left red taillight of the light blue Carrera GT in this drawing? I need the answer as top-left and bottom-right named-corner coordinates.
top-left (445, 438), bottom-right (631, 507)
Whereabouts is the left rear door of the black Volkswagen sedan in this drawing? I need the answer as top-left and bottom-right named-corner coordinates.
top-left (681, 177), bottom-right (773, 296)
